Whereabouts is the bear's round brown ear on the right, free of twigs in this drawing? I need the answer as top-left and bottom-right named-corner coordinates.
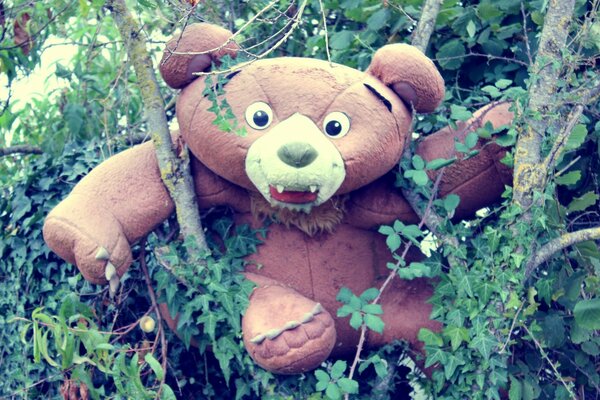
top-left (367, 44), bottom-right (444, 112)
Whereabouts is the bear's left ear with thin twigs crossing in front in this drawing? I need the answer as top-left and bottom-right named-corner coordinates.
top-left (160, 23), bottom-right (239, 89)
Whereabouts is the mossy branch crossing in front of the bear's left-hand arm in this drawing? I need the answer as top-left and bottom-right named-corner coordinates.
top-left (106, 0), bottom-right (208, 251)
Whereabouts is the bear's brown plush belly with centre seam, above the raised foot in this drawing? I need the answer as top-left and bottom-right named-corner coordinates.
top-left (236, 214), bottom-right (391, 305)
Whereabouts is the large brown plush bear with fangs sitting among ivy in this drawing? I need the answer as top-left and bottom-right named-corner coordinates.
top-left (44, 24), bottom-right (511, 373)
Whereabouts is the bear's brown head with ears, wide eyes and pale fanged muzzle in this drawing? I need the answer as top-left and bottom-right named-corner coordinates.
top-left (160, 24), bottom-right (444, 212)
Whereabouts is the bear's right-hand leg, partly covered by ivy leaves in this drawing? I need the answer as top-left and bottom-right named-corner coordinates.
top-left (368, 277), bottom-right (441, 362)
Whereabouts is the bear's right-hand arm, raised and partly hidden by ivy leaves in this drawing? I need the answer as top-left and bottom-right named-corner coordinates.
top-left (346, 103), bottom-right (513, 229)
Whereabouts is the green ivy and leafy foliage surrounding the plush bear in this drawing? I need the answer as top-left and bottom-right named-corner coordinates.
top-left (0, 0), bottom-right (600, 399)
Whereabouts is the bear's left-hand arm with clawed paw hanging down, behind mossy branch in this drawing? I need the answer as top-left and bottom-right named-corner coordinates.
top-left (43, 142), bottom-right (245, 283)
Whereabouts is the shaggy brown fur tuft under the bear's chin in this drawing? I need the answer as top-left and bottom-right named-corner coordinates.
top-left (250, 193), bottom-right (348, 237)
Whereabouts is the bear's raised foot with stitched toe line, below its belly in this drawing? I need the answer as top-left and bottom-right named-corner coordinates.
top-left (242, 273), bottom-right (336, 374)
